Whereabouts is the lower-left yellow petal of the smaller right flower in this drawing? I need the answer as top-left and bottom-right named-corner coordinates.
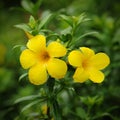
top-left (73, 68), bottom-right (89, 83)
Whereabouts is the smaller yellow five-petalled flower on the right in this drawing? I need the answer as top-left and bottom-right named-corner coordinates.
top-left (68, 47), bottom-right (110, 83)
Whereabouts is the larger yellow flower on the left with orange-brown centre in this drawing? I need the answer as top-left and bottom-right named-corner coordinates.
top-left (20, 35), bottom-right (67, 85)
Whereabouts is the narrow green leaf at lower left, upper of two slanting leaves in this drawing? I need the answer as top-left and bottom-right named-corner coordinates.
top-left (14, 95), bottom-right (40, 104)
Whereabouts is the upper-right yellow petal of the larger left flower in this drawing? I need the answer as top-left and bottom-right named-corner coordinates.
top-left (47, 42), bottom-right (67, 57)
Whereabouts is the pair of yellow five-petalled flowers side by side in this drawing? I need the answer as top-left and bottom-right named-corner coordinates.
top-left (20, 35), bottom-right (110, 85)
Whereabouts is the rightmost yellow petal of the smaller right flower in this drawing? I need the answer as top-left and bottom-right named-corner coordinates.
top-left (90, 53), bottom-right (110, 70)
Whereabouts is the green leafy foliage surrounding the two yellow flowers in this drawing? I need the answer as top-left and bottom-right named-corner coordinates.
top-left (0, 0), bottom-right (120, 120)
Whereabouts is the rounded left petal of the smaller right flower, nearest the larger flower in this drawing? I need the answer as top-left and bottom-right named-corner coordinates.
top-left (68, 50), bottom-right (83, 67)
